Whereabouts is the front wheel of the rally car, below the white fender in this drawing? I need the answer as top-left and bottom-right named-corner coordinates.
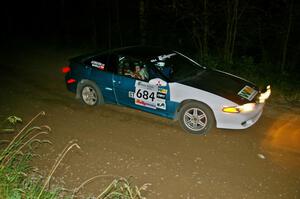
top-left (178, 102), bottom-right (215, 134)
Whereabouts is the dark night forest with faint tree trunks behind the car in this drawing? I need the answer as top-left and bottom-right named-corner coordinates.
top-left (0, 0), bottom-right (300, 84)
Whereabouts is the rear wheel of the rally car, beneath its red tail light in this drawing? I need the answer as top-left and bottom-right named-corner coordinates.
top-left (79, 81), bottom-right (104, 106)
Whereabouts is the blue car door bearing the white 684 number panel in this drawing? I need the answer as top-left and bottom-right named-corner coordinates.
top-left (113, 54), bottom-right (174, 117)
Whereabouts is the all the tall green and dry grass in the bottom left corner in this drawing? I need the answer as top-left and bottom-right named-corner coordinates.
top-left (0, 111), bottom-right (149, 199)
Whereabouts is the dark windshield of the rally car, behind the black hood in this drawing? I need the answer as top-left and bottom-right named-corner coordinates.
top-left (151, 52), bottom-right (205, 82)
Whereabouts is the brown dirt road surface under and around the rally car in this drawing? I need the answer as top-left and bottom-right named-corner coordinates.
top-left (0, 46), bottom-right (300, 199)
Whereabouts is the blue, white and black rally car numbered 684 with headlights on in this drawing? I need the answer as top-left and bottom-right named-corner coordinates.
top-left (62, 46), bottom-right (271, 134)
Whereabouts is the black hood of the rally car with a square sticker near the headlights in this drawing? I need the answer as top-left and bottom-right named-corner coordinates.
top-left (180, 69), bottom-right (259, 105)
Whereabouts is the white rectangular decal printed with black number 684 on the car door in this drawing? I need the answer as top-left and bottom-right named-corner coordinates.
top-left (134, 81), bottom-right (158, 109)
